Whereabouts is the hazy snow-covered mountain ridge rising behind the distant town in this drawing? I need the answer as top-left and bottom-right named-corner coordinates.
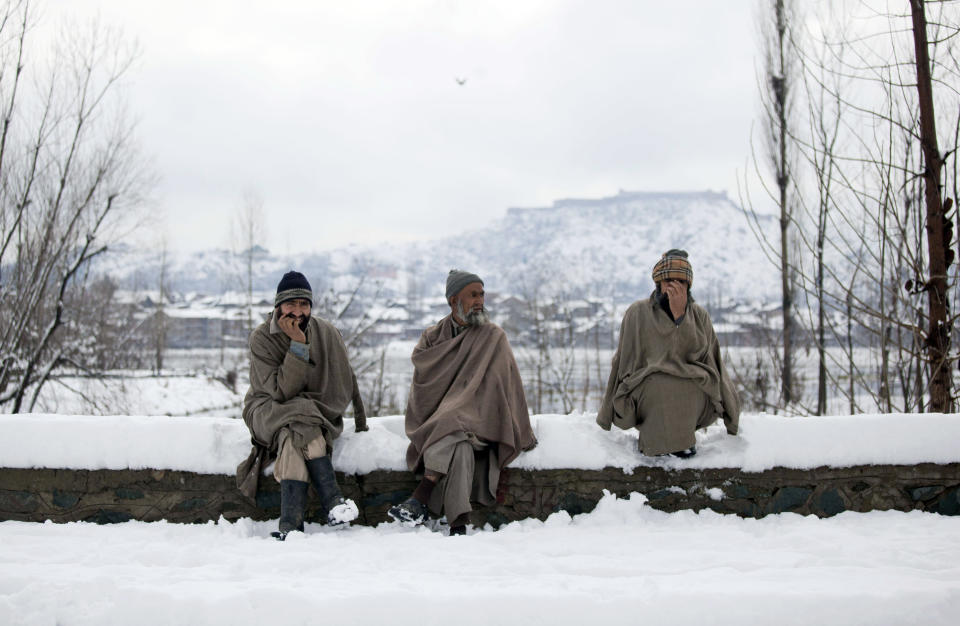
top-left (101, 191), bottom-right (779, 301)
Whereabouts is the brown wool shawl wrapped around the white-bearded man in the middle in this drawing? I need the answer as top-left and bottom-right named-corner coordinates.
top-left (405, 315), bottom-right (537, 471)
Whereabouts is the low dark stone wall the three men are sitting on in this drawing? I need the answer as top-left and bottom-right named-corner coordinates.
top-left (0, 463), bottom-right (960, 526)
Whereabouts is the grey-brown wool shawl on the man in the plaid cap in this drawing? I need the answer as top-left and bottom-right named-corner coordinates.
top-left (597, 293), bottom-right (740, 435)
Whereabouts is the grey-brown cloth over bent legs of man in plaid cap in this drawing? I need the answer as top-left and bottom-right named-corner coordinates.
top-left (637, 374), bottom-right (716, 456)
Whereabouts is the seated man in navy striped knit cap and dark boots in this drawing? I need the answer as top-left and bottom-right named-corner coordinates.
top-left (237, 271), bottom-right (367, 541)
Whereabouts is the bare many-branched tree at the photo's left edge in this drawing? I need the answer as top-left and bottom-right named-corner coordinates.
top-left (0, 1), bottom-right (147, 412)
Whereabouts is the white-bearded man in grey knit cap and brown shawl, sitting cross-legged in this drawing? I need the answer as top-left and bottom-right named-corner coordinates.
top-left (389, 270), bottom-right (537, 535)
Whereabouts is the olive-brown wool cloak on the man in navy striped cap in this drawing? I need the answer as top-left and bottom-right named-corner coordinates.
top-left (237, 314), bottom-right (366, 499)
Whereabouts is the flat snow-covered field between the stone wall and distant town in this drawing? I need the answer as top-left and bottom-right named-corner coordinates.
top-left (24, 342), bottom-right (936, 417)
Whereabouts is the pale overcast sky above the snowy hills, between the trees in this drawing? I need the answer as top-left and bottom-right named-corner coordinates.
top-left (44, 0), bottom-right (758, 251)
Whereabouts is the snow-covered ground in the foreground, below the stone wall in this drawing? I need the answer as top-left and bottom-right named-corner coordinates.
top-left (0, 495), bottom-right (960, 626)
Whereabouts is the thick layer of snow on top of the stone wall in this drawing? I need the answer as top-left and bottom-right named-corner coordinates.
top-left (0, 413), bottom-right (960, 474)
